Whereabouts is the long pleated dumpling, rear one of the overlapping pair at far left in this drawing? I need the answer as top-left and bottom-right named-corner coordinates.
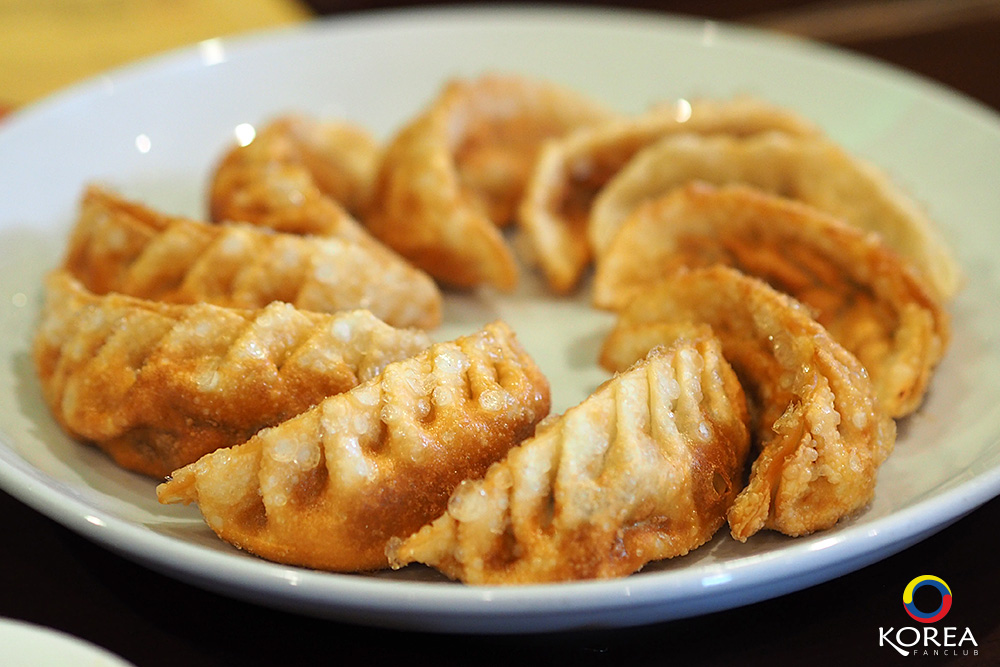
top-left (64, 187), bottom-right (442, 328)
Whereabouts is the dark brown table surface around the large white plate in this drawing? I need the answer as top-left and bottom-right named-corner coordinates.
top-left (0, 0), bottom-right (1000, 667)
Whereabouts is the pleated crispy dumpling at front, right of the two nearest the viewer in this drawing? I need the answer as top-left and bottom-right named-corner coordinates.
top-left (388, 336), bottom-right (749, 584)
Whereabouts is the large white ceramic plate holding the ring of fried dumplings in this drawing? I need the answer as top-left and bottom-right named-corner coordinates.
top-left (0, 8), bottom-right (1000, 632)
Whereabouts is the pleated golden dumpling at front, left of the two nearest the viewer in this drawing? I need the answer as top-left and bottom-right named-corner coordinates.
top-left (157, 322), bottom-right (549, 571)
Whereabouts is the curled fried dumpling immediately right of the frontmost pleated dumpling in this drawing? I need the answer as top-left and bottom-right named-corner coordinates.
top-left (602, 266), bottom-right (896, 541)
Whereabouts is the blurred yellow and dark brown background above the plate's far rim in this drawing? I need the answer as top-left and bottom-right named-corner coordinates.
top-left (0, 0), bottom-right (1000, 114)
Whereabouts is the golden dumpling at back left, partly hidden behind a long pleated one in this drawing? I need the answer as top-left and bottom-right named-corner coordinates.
top-left (209, 115), bottom-right (382, 242)
